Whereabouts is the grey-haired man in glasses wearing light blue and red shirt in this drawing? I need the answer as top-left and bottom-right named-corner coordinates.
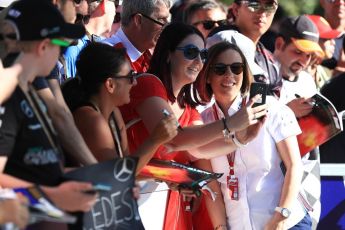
top-left (104, 0), bottom-right (171, 72)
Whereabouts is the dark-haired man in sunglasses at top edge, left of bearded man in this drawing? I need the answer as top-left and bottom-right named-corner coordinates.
top-left (230, 0), bottom-right (282, 98)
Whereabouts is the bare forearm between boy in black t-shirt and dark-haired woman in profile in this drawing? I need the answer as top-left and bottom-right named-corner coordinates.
top-left (38, 79), bottom-right (97, 165)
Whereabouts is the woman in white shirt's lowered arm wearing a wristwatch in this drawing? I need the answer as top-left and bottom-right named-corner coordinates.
top-left (265, 136), bottom-right (303, 230)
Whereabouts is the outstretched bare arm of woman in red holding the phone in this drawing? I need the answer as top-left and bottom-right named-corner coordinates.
top-left (136, 96), bottom-right (267, 154)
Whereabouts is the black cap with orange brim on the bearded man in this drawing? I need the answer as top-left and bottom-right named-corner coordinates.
top-left (279, 15), bottom-right (324, 56)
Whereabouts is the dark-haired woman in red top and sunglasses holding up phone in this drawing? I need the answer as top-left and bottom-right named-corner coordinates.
top-left (121, 23), bottom-right (266, 229)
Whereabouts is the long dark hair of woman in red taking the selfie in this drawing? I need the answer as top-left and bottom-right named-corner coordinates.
top-left (148, 23), bottom-right (204, 108)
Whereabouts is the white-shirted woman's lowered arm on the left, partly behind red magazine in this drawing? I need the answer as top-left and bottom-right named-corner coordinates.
top-left (193, 160), bottom-right (227, 230)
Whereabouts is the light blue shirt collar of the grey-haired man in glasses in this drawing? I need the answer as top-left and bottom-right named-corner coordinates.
top-left (102, 28), bottom-right (142, 62)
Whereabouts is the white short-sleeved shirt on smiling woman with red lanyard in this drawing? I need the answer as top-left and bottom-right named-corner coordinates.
top-left (201, 96), bottom-right (305, 230)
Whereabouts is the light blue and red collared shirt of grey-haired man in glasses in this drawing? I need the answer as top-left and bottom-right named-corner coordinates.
top-left (103, 28), bottom-right (151, 72)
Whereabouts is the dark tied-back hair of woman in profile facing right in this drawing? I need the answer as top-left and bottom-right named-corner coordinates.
top-left (62, 42), bottom-right (127, 111)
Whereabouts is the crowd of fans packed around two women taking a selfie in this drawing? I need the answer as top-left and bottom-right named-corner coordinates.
top-left (0, 0), bottom-right (345, 230)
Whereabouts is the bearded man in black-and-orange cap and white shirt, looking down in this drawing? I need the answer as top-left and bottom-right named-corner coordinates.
top-left (274, 15), bottom-right (324, 228)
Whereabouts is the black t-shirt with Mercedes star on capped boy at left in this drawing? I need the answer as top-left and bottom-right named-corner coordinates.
top-left (0, 87), bottom-right (63, 186)
